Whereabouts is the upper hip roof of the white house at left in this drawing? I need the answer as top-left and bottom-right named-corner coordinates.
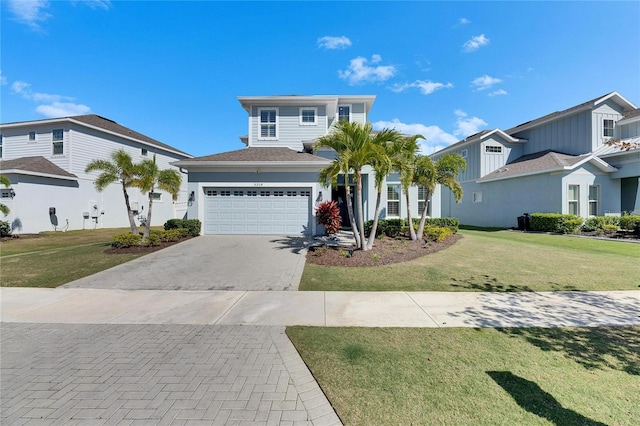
top-left (0, 114), bottom-right (191, 157)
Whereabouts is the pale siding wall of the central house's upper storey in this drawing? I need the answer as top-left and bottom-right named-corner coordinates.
top-left (249, 105), bottom-right (327, 150)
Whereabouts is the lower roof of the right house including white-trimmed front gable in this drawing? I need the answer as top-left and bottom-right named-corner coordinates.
top-left (478, 150), bottom-right (617, 182)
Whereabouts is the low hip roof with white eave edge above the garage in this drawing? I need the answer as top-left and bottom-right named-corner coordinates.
top-left (171, 147), bottom-right (330, 168)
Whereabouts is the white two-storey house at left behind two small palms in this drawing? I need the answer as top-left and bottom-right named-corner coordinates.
top-left (0, 115), bottom-right (191, 233)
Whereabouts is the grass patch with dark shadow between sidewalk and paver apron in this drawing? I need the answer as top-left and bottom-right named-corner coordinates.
top-left (287, 327), bottom-right (640, 426)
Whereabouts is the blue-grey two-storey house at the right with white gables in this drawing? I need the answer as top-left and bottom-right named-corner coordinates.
top-left (432, 92), bottom-right (640, 227)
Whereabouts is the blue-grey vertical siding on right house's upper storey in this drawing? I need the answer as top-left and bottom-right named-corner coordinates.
top-left (512, 111), bottom-right (592, 155)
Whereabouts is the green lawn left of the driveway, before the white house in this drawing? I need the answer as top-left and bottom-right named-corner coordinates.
top-left (0, 228), bottom-right (141, 287)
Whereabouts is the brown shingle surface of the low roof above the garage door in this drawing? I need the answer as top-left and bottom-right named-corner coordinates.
top-left (178, 147), bottom-right (329, 163)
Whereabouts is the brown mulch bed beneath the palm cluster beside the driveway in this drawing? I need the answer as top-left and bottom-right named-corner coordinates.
top-left (307, 234), bottom-right (462, 266)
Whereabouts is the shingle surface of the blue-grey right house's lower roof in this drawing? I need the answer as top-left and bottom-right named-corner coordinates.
top-left (479, 150), bottom-right (589, 182)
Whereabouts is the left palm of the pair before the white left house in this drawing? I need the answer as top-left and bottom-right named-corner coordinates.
top-left (85, 149), bottom-right (138, 234)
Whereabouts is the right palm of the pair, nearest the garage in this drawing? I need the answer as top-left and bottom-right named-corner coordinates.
top-left (131, 154), bottom-right (182, 243)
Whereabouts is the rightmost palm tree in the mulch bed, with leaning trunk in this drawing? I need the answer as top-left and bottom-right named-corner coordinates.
top-left (414, 154), bottom-right (467, 239)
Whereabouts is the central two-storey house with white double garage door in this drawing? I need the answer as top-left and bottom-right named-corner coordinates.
top-left (173, 95), bottom-right (430, 235)
